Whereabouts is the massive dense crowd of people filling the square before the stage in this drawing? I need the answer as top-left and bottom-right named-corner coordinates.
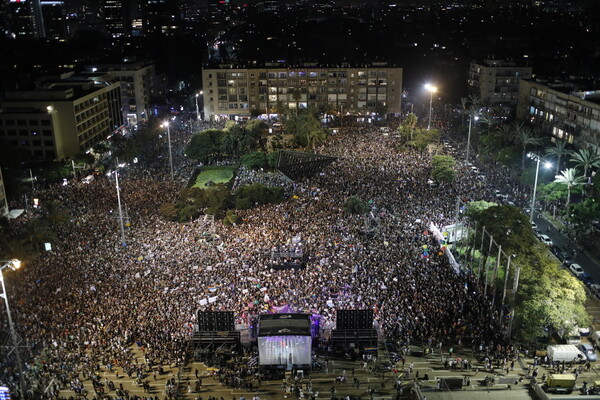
top-left (3, 117), bottom-right (524, 398)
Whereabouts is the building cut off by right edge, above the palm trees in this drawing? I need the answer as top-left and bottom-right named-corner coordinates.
top-left (517, 80), bottom-right (600, 152)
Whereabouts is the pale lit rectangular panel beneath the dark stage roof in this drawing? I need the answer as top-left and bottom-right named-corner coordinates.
top-left (258, 336), bottom-right (312, 365)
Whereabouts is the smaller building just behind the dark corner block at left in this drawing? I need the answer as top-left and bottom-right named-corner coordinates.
top-left (86, 61), bottom-right (155, 125)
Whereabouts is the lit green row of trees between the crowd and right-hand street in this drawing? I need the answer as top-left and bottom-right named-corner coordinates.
top-left (467, 202), bottom-right (591, 341)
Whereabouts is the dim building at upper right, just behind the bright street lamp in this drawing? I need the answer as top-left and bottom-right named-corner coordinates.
top-left (468, 60), bottom-right (531, 106)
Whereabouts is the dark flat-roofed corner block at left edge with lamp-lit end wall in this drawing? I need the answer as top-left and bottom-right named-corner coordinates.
top-left (0, 73), bottom-right (122, 160)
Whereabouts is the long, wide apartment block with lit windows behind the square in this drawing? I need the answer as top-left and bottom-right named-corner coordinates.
top-left (202, 63), bottom-right (402, 118)
